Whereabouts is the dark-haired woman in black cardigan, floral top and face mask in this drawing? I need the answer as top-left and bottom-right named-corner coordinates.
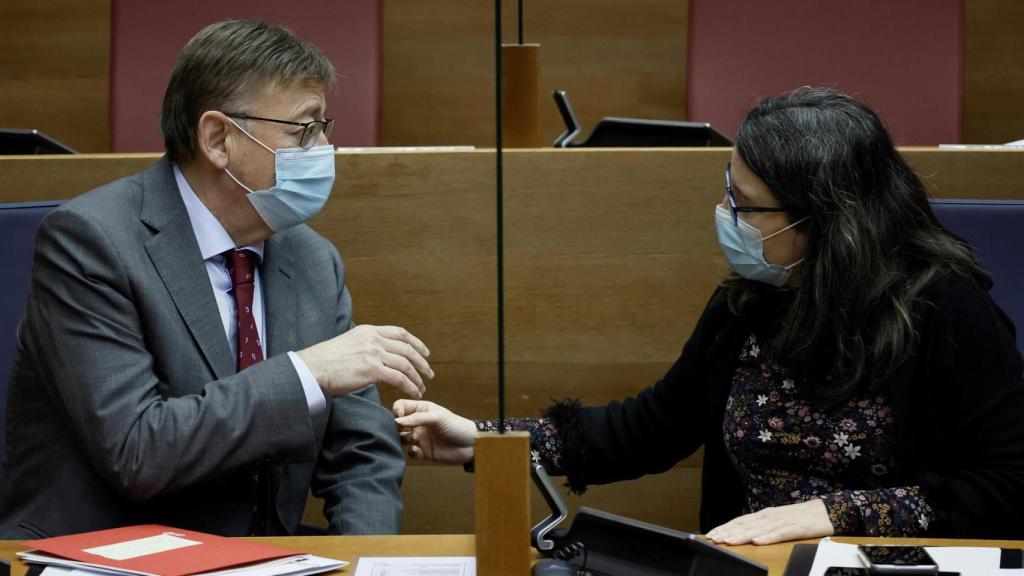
top-left (394, 88), bottom-right (1024, 544)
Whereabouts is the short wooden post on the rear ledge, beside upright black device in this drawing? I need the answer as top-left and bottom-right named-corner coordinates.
top-left (502, 44), bottom-right (541, 148)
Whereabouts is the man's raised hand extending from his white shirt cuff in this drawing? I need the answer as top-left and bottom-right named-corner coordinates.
top-left (296, 325), bottom-right (434, 398)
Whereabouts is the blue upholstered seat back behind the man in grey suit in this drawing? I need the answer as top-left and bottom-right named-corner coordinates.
top-left (0, 202), bottom-right (60, 463)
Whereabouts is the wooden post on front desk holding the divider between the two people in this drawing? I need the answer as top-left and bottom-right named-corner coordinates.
top-left (474, 433), bottom-right (532, 576)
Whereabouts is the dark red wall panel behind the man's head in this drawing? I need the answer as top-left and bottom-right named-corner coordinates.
top-left (111, 0), bottom-right (381, 152)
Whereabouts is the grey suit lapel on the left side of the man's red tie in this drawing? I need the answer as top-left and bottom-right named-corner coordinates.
top-left (139, 158), bottom-right (234, 378)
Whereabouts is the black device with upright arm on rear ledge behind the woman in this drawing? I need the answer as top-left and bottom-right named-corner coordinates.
top-left (552, 90), bottom-right (732, 148)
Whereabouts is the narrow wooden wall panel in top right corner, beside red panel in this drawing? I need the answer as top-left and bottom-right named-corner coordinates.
top-left (964, 0), bottom-right (1024, 143)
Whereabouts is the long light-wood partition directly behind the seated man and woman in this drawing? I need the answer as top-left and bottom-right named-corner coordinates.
top-left (0, 149), bottom-right (1024, 533)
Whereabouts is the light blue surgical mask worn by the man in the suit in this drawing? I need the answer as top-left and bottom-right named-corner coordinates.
top-left (224, 118), bottom-right (334, 232)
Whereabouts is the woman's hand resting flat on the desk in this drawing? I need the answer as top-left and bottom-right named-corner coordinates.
top-left (708, 498), bottom-right (834, 545)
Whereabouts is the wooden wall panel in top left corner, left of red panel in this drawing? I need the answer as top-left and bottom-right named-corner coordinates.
top-left (0, 0), bottom-right (111, 152)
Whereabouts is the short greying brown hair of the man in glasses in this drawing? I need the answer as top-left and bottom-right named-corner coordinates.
top-left (160, 20), bottom-right (335, 163)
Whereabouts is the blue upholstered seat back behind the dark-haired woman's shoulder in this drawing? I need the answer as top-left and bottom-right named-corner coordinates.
top-left (932, 200), bottom-right (1024, 353)
